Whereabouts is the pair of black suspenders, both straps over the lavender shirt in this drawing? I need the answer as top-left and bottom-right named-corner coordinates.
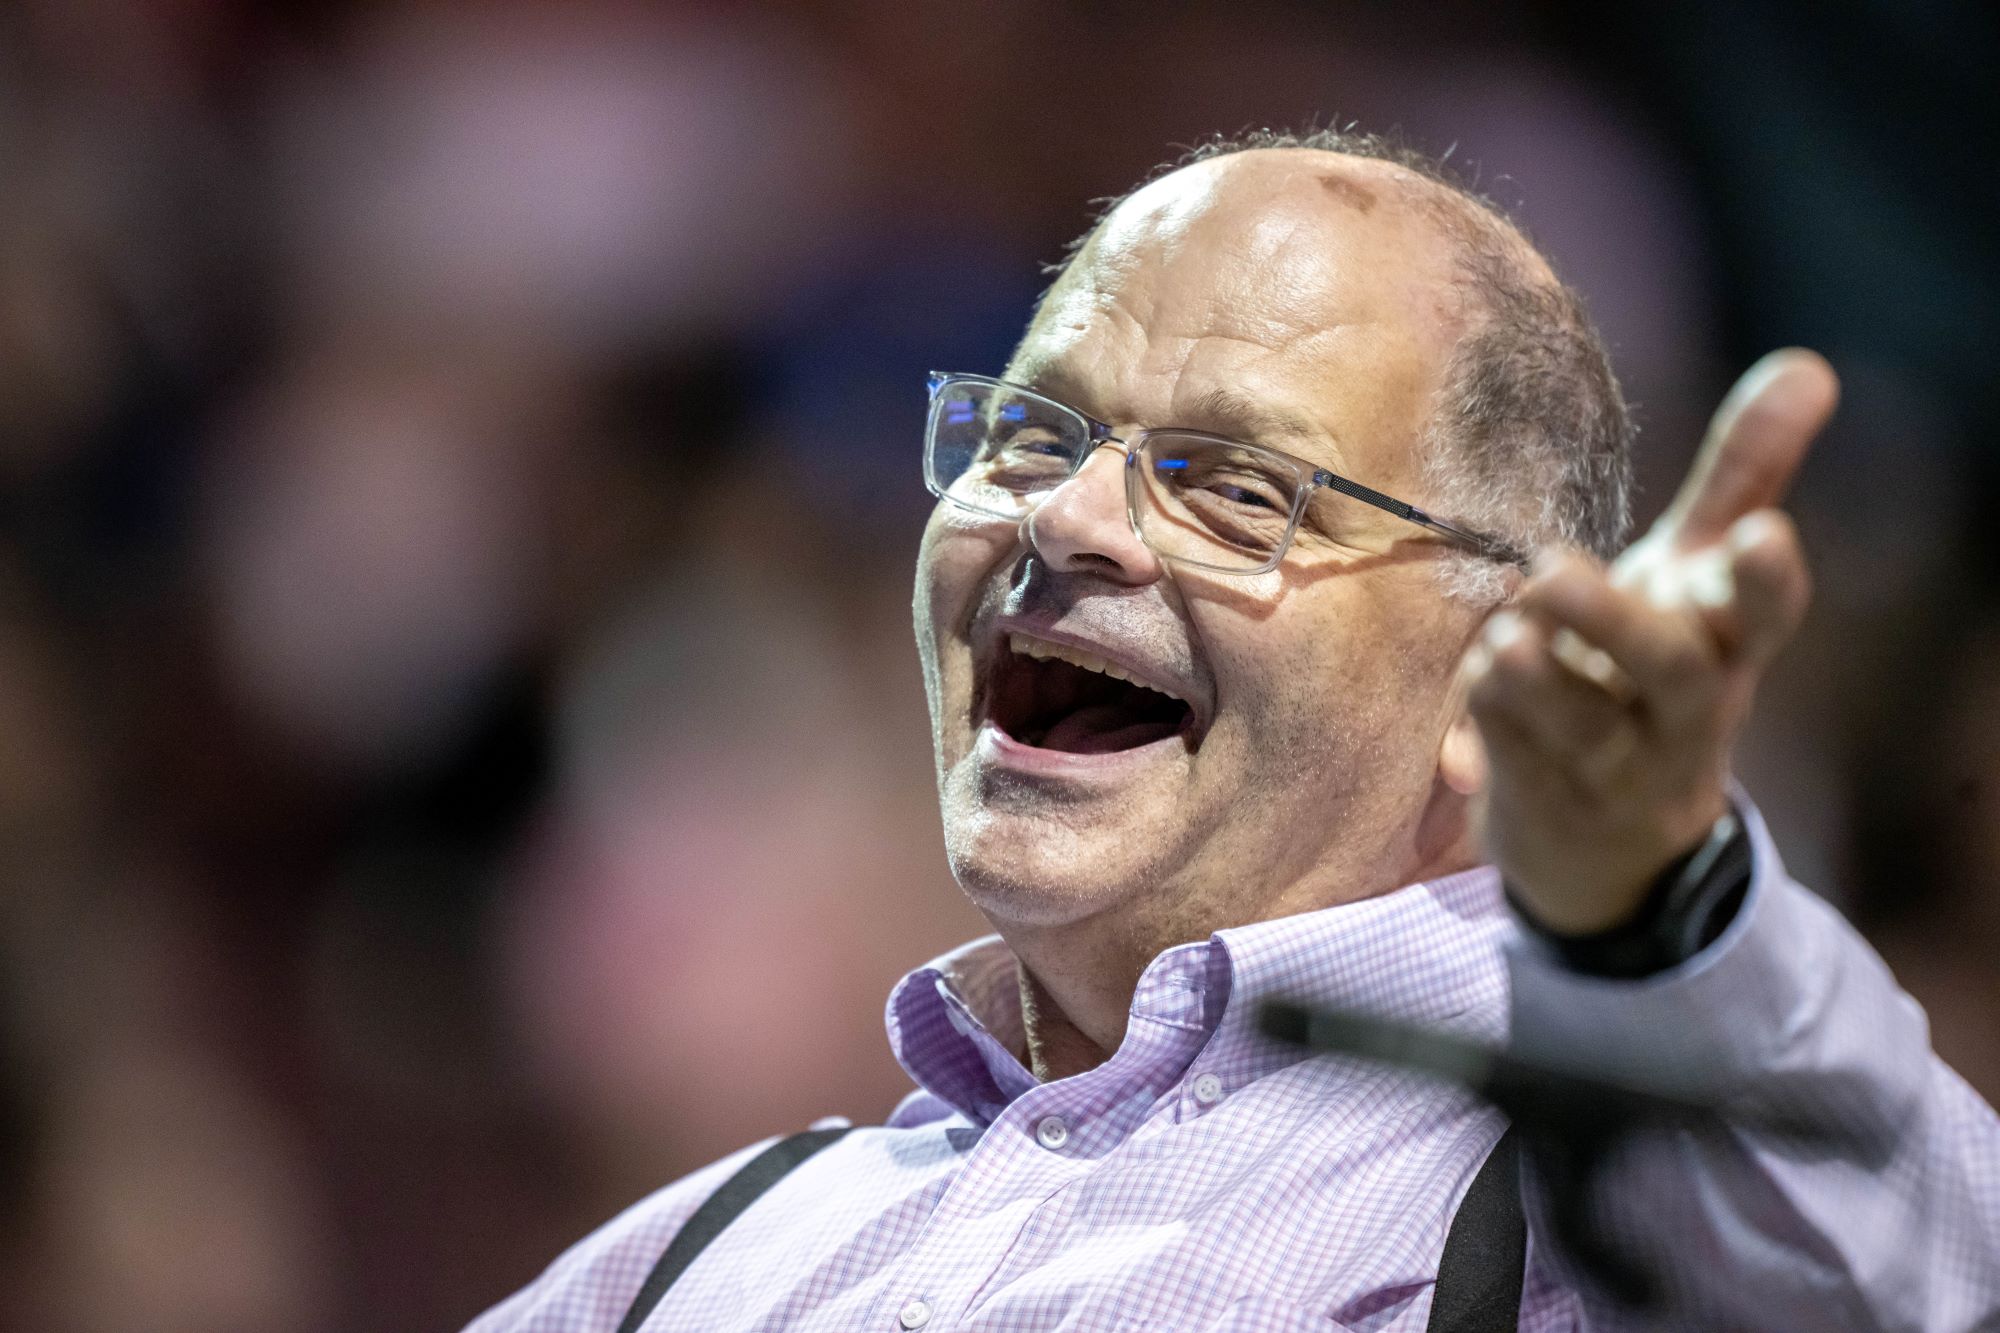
top-left (618, 1129), bottom-right (1528, 1333)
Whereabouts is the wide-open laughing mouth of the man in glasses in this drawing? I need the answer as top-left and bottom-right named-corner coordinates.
top-left (986, 634), bottom-right (1194, 755)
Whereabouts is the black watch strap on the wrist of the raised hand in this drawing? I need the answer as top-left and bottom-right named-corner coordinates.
top-left (1508, 809), bottom-right (1752, 981)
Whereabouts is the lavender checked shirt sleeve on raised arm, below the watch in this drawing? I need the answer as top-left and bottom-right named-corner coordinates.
top-left (1508, 803), bottom-right (2000, 1333)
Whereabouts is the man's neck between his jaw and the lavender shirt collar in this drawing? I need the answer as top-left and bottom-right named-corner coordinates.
top-left (994, 780), bottom-right (1478, 1083)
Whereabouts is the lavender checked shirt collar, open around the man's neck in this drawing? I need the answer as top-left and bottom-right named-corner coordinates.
top-left (886, 867), bottom-right (1512, 1125)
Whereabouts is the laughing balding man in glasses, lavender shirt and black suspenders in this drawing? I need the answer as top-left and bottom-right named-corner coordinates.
top-left (474, 134), bottom-right (2000, 1333)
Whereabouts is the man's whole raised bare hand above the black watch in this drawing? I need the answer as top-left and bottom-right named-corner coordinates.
top-left (1464, 348), bottom-right (1838, 935)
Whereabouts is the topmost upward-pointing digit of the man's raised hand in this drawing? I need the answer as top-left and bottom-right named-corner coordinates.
top-left (1660, 346), bottom-right (1840, 550)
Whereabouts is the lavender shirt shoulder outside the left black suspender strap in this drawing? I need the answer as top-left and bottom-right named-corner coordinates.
top-left (466, 1139), bottom-right (776, 1333)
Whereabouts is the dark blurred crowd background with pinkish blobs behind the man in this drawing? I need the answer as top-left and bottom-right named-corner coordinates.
top-left (0, 0), bottom-right (2000, 1333)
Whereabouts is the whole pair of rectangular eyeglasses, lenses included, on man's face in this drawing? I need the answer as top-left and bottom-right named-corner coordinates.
top-left (924, 370), bottom-right (1522, 574)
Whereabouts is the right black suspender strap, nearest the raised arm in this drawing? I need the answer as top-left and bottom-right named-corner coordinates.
top-left (1424, 1127), bottom-right (1528, 1333)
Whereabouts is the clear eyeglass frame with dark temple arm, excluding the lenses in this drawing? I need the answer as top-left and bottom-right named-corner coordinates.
top-left (924, 370), bottom-right (1526, 576)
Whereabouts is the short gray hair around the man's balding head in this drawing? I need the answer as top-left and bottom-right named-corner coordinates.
top-left (1054, 126), bottom-right (1636, 602)
